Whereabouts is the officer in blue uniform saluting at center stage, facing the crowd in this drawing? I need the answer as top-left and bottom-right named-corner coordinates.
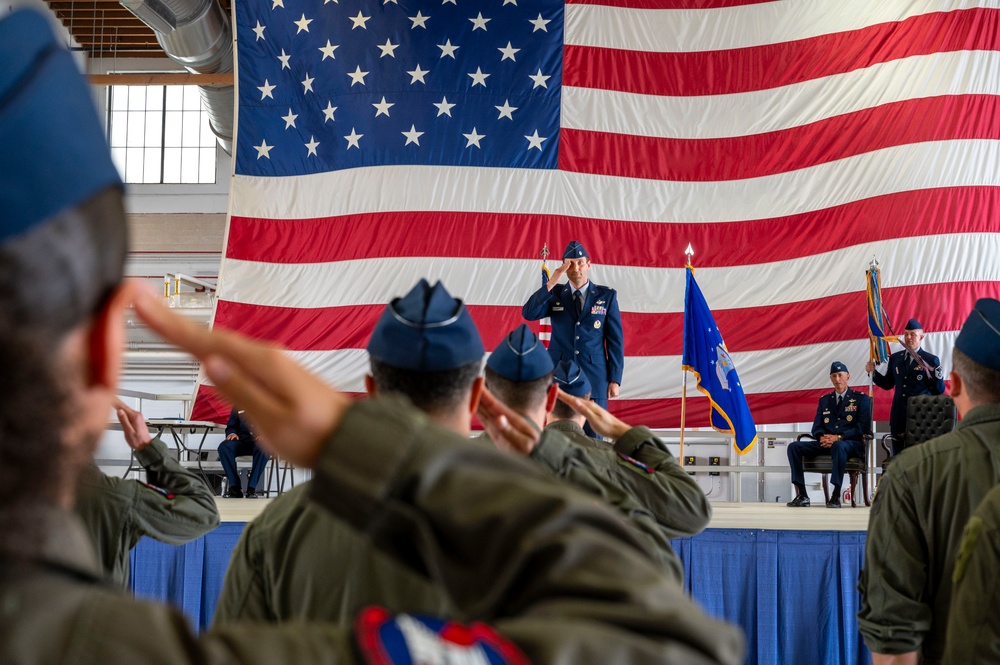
top-left (521, 240), bottom-right (625, 420)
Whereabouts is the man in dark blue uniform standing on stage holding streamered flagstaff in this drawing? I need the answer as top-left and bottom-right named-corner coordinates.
top-left (865, 319), bottom-right (944, 456)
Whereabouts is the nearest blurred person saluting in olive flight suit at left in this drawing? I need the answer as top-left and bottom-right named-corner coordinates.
top-left (0, 9), bottom-right (744, 665)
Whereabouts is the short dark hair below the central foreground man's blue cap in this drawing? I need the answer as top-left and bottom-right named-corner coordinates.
top-left (370, 358), bottom-right (483, 414)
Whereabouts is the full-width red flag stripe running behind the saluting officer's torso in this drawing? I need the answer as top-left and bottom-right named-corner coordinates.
top-left (216, 284), bottom-right (1000, 356)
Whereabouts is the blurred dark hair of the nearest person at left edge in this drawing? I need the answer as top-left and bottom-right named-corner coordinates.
top-left (0, 187), bottom-right (128, 546)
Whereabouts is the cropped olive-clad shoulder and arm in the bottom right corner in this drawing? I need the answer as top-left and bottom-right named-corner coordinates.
top-left (942, 486), bottom-right (1000, 665)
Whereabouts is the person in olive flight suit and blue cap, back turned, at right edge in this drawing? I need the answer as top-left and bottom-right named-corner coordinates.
top-left (858, 298), bottom-right (1000, 665)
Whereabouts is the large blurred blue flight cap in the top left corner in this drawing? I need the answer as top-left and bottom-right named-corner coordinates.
top-left (0, 9), bottom-right (121, 242)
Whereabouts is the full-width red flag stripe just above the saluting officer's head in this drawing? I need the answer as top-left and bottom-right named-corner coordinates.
top-left (226, 187), bottom-right (1000, 268)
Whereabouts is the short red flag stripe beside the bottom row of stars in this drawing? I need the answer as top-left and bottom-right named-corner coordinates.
top-left (559, 95), bottom-right (1000, 182)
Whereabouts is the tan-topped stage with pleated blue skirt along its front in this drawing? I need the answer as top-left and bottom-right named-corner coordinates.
top-left (132, 494), bottom-right (871, 665)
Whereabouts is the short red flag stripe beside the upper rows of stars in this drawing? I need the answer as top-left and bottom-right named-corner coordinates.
top-left (563, 8), bottom-right (1000, 96)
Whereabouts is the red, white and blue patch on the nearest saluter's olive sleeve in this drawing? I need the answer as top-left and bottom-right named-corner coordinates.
top-left (354, 607), bottom-right (529, 665)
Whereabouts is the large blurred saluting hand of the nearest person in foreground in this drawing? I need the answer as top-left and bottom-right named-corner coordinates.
top-left (134, 289), bottom-right (351, 467)
